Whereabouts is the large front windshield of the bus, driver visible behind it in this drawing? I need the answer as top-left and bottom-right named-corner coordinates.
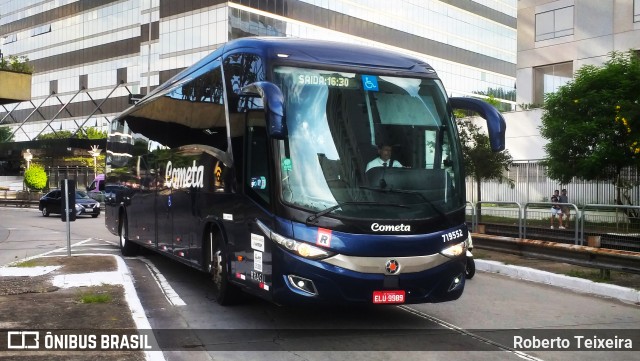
top-left (274, 66), bottom-right (464, 220)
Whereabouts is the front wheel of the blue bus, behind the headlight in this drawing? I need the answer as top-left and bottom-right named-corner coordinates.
top-left (207, 230), bottom-right (240, 306)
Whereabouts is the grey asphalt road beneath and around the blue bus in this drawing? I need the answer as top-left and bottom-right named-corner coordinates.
top-left (0, 208), bottom-right (640, 361)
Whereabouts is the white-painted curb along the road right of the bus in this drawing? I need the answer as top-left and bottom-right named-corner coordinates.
top-left (474, 259), bottom-right (640, 304)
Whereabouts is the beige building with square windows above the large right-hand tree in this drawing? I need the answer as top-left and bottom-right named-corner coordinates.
top-left (517, 0), bottom-right (640, 104)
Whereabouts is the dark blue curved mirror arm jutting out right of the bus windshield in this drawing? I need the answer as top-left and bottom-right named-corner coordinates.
top-left (449, 97), bottom-right (507, 152)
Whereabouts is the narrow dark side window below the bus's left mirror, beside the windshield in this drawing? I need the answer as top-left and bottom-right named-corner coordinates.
top-left (245, 126), bottom-right (271, 204)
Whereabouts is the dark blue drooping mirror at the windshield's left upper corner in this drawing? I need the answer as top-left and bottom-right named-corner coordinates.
top-left (240, 81), bottom-right (288, 139)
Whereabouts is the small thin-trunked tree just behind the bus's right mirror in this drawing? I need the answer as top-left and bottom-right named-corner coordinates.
top-left (458, 118), bottom-right (514, 219)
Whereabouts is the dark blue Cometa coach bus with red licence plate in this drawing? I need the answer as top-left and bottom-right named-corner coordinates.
top-left (105, 37), bottom-right (505, 305)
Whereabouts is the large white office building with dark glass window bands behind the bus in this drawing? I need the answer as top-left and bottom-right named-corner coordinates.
top-left (0, 0), bottom-right (517, 141)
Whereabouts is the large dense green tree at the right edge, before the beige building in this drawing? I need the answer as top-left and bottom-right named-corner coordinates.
top-left (540, 51), bottom-right (640, 208)
